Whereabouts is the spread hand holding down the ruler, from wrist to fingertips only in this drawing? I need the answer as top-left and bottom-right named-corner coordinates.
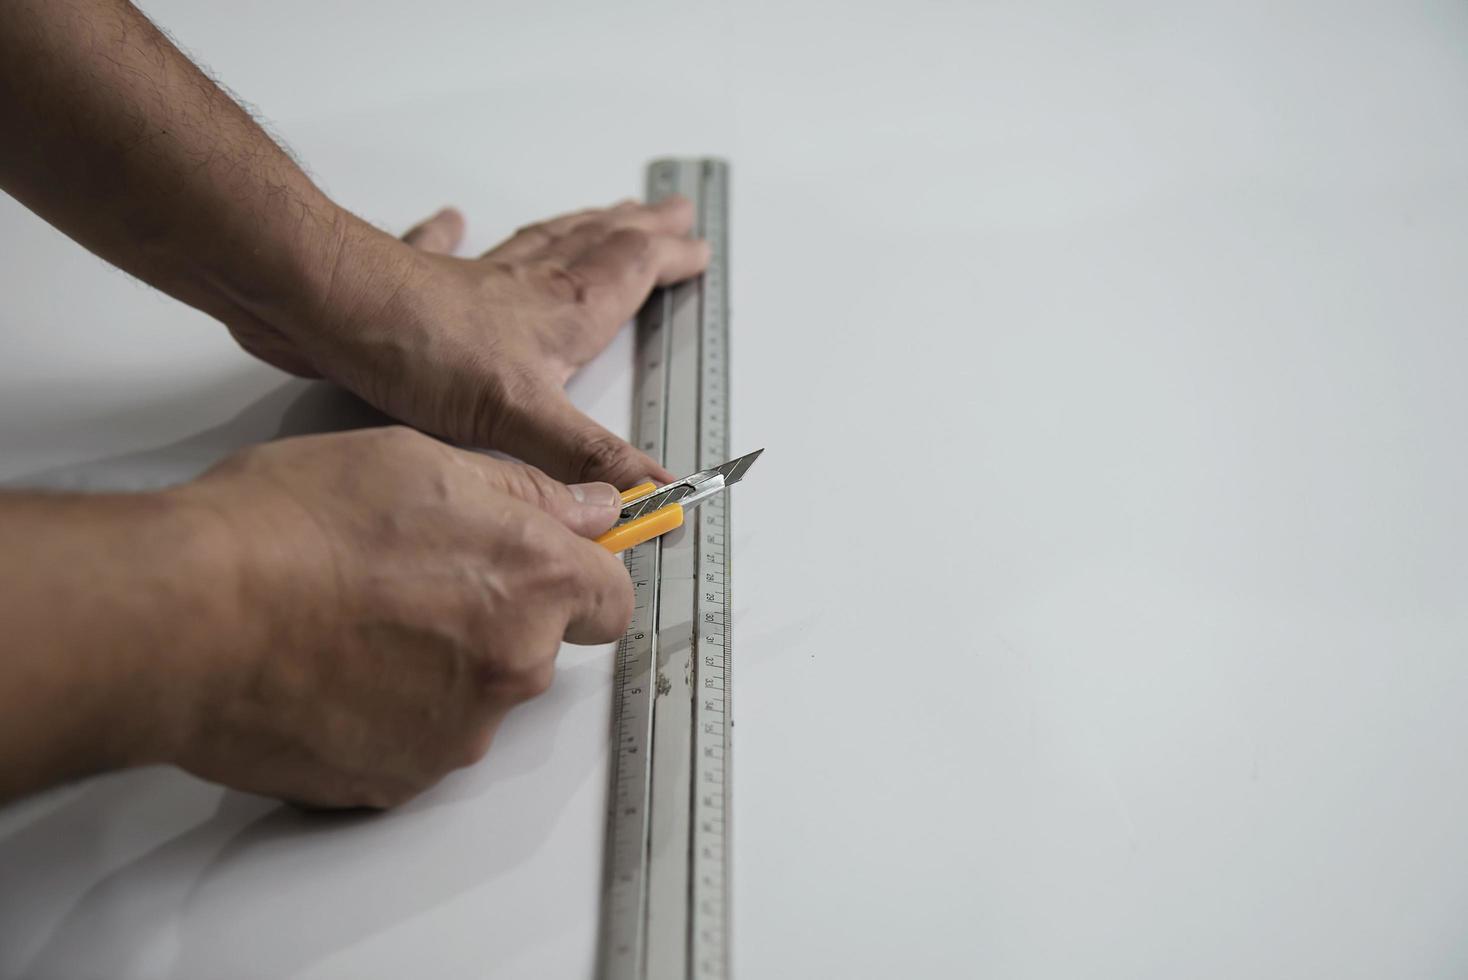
top-left (230, 198), bottom-right (709, 487)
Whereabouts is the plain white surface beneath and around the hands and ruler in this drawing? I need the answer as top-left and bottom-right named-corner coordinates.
top-left (0, 0), bottom-right (1468, 980)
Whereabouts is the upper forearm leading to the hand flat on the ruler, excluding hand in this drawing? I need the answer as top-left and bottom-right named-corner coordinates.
top-left (0, 0), bottom-right (378, 333)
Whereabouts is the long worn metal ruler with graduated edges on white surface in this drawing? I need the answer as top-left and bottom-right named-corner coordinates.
top-left (599, 160), bottom-right (733, 980)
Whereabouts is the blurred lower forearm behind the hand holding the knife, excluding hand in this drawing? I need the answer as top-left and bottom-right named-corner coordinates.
top-left (0, 491), bottom-right (244, 801)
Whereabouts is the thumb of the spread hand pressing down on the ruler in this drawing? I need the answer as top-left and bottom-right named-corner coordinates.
top-left (495, 384), bottom-right (674, 489)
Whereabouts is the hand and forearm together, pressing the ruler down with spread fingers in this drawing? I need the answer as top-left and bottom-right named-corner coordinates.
top-left (0, 0), bottom-right (708, 486)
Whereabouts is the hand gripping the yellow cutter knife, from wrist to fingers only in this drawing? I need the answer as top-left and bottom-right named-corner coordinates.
top-left (170, 428), bottom-right (633, 807)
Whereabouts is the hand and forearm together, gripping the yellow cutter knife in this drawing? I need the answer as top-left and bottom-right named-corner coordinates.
top-left (0, 428), bottom-right (633, 807)
